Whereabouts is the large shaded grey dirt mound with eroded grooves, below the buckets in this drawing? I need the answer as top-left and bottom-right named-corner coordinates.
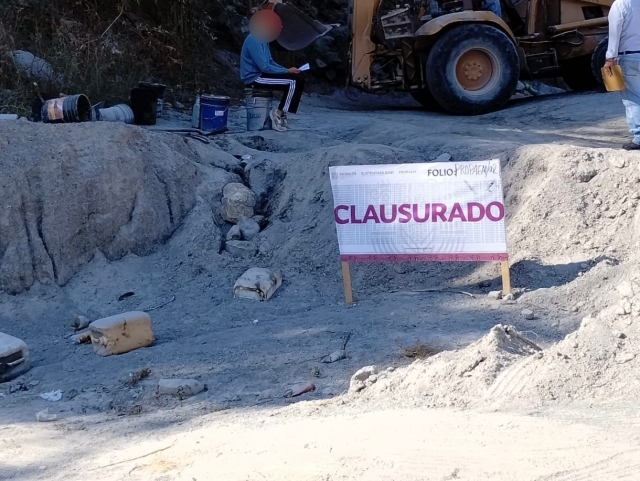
top-left (0, 122), bottom-right (238, 293)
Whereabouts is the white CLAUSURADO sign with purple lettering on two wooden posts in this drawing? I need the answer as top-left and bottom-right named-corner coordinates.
top-left (329, 159), bottom-right (511, 304)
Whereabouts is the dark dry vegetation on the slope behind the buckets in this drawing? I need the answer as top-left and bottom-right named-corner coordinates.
top-left (0, 0), bottom-right (343, 113)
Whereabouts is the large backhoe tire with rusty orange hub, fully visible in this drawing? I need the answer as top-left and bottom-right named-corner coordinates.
top-left (426, 24), bottom-right (520, 115)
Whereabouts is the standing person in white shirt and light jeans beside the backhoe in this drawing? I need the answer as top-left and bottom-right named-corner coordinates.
top-left (604, 0), bottom-right (640, 150)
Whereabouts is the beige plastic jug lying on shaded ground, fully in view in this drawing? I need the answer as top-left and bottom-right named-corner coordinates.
top-left (90, 311), bottom-right (155, 356)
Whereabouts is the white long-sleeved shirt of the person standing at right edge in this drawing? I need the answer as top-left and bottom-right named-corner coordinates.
top-left (607, 0), bottom-right (640, 59)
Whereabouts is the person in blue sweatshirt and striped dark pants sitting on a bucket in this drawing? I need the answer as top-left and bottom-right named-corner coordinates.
top-left (240, 10), bottom-right (304, 132)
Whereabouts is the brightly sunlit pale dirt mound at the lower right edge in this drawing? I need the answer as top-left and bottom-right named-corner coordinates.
top-left (489, 277), bottom-right (640, 405)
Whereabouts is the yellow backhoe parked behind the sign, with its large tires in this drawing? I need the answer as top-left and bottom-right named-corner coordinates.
top-left (267, 0), bottom-right (612, 115)
